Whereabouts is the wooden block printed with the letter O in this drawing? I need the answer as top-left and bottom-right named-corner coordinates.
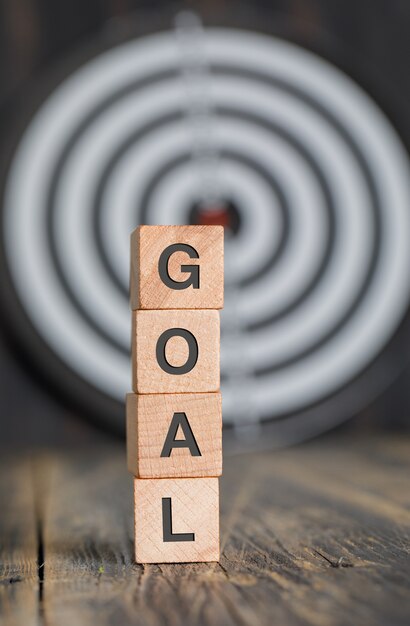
top-left (132, 310), bottom-right (220, 393)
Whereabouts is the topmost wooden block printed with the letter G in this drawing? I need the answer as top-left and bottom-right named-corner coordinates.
top-left (130, 226), bottom-right (224, 310)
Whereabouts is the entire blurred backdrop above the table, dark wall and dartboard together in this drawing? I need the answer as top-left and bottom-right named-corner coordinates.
top-left (0, 0), bottom-right (410, 451)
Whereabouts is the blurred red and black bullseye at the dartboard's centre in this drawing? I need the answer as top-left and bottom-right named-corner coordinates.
top-left (189, 200), bottom-right (241, 235)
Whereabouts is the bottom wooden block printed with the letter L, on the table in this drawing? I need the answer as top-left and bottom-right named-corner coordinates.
top-left (134, 478), bottom-right (219, 563)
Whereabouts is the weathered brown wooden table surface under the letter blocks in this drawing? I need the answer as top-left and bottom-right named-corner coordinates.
top-left (0, 436), bottom-right (410, 626)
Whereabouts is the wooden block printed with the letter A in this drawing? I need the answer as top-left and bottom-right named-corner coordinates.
top-left (127, 393), bottom-right (222, 478)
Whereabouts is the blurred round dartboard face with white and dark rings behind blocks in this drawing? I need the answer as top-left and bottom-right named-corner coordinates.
top-left (3, 22), bottom-right (410, 445)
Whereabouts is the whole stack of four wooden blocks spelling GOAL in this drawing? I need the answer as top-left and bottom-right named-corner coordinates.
top-left (127, 226), bottom-right (224, 563)
